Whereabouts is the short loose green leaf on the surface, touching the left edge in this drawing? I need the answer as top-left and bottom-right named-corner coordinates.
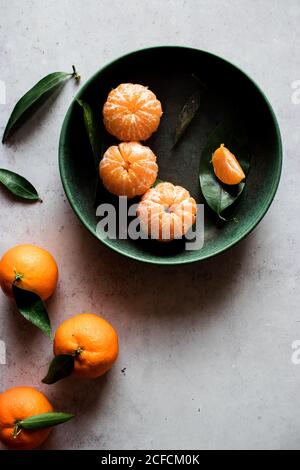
top-left (0, 168), bottom-right (40, 201)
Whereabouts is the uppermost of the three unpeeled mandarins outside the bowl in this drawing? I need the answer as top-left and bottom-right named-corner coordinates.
top-left (0, 245), bottom-right (58, 300)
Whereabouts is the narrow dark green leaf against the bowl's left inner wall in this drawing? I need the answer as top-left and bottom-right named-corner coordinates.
top-left (77, 99), bottom-right (103, 171)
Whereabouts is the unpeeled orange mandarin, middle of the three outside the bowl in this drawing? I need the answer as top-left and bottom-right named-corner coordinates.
top-left (53, 313), bottom-right (118, 378)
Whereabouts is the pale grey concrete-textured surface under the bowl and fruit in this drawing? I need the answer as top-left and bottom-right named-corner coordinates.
top-left (0, 0), bottom-right (300, 449)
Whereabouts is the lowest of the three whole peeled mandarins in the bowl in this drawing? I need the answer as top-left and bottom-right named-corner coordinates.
top-left (137, 183), bottom-right (197, 241)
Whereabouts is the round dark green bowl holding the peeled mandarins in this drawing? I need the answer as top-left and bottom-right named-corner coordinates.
top-left (59, 47), bottom-right (282, 264)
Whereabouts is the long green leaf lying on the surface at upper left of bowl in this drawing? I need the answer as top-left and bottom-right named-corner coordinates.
top-left (2, 72), bottom-right (72, 143)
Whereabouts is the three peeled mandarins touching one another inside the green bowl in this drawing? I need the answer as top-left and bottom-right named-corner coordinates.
top-left (99, 83), bottom-right (197, 241)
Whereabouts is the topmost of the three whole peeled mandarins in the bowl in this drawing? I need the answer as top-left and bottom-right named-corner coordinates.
top-left (103, 83), bottom-right (162, 141)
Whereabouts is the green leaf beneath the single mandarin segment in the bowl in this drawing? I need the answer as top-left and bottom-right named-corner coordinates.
top-left (199, 116), bottom-right (250, 220)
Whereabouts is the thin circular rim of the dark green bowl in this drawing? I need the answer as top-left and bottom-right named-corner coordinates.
top-left (58, 45), bottom-right (283, 266)
